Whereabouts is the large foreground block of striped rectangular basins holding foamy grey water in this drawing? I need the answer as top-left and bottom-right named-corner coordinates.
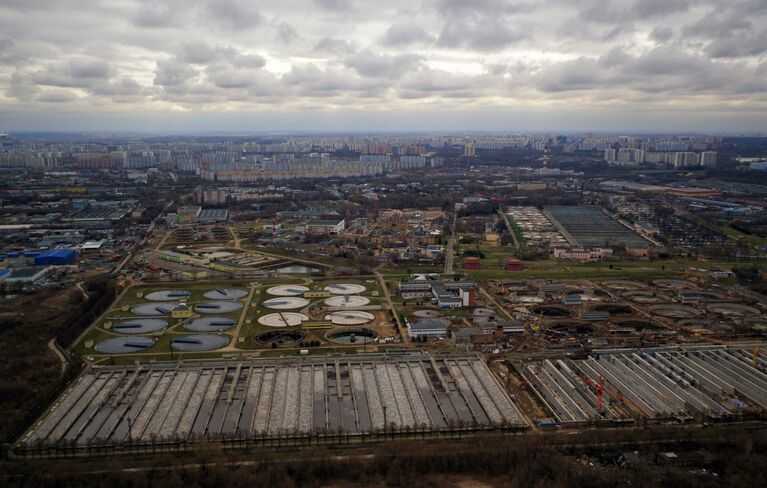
top-left (19, 352), bottom-right (528, 452)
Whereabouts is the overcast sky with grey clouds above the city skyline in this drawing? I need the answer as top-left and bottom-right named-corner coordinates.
top-left (0, 0), bottom-right (767, 131)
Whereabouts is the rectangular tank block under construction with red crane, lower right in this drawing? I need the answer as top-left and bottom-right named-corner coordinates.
top-left (509, 346), bottom-right (767, 427)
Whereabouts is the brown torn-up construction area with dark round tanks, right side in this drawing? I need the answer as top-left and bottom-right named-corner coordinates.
top-left (490, 277), bottom-right (767, 351)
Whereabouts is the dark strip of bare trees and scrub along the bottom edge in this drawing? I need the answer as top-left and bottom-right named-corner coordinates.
top-left (6, 427), bottom-right (767, 488)
